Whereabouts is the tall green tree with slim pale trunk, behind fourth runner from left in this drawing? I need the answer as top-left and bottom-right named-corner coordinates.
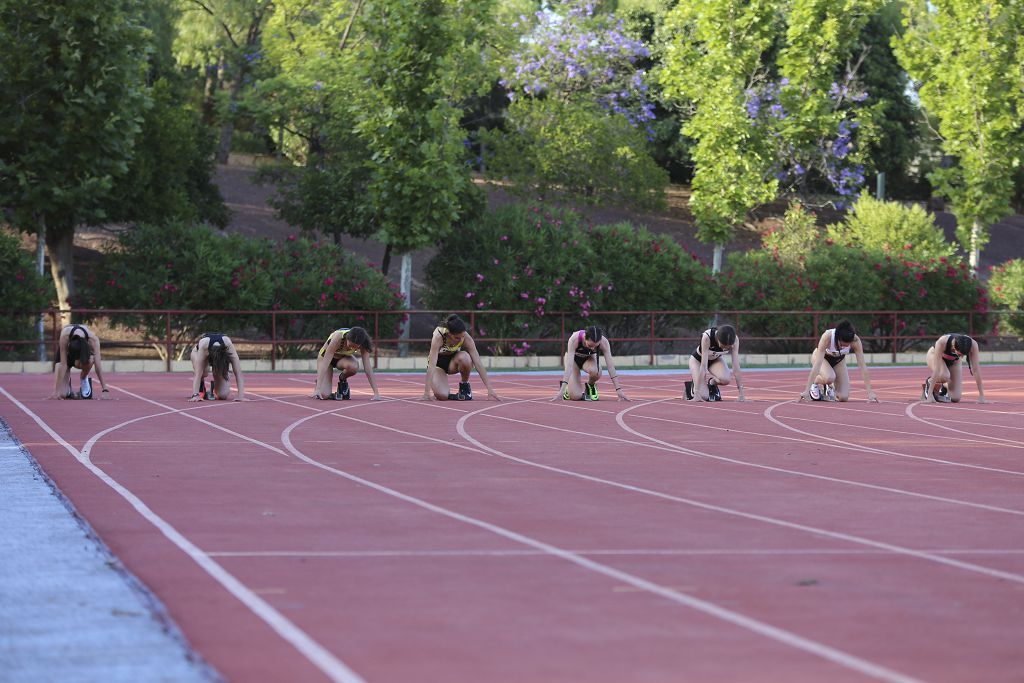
top-left (348, 0), bottom-right (490, 303)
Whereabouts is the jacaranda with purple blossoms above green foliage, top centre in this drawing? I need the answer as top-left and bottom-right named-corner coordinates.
top-left (481, 0), bottom-right (667, 206)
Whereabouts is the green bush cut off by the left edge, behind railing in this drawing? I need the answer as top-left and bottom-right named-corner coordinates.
top-left (0, 230), bottom-right (54, 360)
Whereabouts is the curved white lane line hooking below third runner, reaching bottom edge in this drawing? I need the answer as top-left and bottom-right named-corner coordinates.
top-left (281, 407), bottom-right (916, 683)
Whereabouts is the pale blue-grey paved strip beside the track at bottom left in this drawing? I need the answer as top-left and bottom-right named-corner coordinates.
top-left (0, 420), bottom-right (223, 683)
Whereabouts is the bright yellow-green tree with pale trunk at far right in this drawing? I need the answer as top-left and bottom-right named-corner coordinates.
top-left (894, 0), bottom-right (1024, 271)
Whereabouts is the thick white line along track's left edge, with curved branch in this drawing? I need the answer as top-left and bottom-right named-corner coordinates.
top-left (0, 387), bottom-right (362, 683)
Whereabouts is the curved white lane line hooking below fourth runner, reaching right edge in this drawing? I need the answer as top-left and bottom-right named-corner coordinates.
top-left (457, 399), bottom-right (1024, 584)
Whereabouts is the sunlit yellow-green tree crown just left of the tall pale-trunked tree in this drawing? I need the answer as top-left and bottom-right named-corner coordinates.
top-left (250, 0), bottom-right (376, 243)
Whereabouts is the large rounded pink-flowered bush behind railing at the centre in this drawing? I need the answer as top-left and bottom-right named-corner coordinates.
top-left (426, 205), bottom-right (716, 353)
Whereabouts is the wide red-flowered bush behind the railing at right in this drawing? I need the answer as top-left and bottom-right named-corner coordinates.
top-left (720, 240), bottom-right (988, 352)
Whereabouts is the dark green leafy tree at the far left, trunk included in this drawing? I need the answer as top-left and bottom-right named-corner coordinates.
top-left (0, 0), bottom-right (148, 317)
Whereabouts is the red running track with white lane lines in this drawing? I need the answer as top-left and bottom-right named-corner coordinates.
top-left (0, 367), bottom-right (1024, 683)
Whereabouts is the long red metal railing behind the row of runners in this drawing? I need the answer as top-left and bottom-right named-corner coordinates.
top-left (0, 308), bottom-right (1021, 372)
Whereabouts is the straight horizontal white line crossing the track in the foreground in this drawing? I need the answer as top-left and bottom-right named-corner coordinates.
top-left (206, 548), bottom-right (1024, 558)
